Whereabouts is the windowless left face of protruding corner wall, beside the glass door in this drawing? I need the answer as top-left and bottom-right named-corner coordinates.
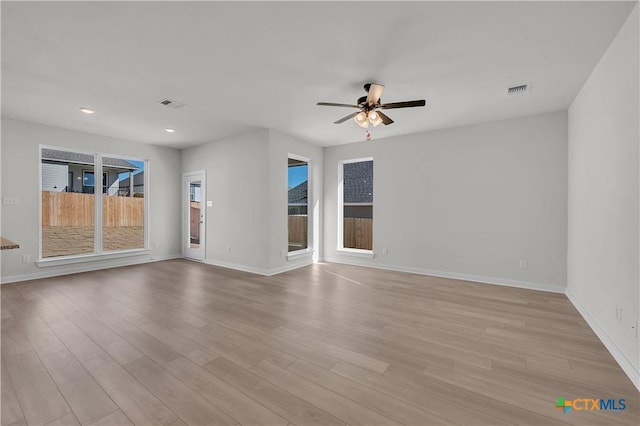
top-left (176, 129), bottom-right (270, 274)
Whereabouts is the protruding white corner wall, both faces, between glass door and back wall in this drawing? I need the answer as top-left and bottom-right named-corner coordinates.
top-left (182, 129), bottom-right (322, 274)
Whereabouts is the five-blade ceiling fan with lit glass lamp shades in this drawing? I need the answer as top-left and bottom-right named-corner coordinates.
top-left (318, 83), bottom-right (426, 129)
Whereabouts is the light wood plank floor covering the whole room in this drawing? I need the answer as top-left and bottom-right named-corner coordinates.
top-left (1, 260), bottom-right (640, 426)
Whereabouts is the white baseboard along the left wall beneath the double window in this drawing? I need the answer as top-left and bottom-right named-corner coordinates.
top-left (0, 254), bottom-right (182, 284)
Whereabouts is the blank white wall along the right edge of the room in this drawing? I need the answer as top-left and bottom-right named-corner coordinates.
top-left (568, 6), bottom-right (640, 388)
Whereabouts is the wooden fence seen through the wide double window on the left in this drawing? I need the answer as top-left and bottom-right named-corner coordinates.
top-left (42, 191), bottom-right (144, 227)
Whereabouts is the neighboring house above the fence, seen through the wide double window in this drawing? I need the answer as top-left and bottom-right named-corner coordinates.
top-left (42, 149), bottom-right (139, 195)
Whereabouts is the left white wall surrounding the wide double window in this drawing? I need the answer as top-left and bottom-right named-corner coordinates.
top-left (1, 118), bottom-right (180, 282)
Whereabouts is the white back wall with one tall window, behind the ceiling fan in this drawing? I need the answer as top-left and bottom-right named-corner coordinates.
top-left (324, 112), bottom-right (567, 291)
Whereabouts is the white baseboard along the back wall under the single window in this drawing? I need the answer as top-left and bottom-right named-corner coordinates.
top-left (325, 257), bottom-right (565, 293)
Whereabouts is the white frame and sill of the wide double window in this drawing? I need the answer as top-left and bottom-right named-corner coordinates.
top-left (36, 145), bottom-right (150, 267)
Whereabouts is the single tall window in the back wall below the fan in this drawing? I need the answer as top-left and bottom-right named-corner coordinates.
top-left (339, 158), bottom-right (373, 251)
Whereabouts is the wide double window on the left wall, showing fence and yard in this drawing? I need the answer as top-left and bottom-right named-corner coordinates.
top-left (40, 148), bottom-right (147, 259)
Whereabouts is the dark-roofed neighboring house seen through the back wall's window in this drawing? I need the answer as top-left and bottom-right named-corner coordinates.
top-left (342, 161), bottom-right (373, 219)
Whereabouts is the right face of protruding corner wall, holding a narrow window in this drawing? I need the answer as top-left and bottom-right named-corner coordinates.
top-left (268, 130), bottom-right (323, 273)
